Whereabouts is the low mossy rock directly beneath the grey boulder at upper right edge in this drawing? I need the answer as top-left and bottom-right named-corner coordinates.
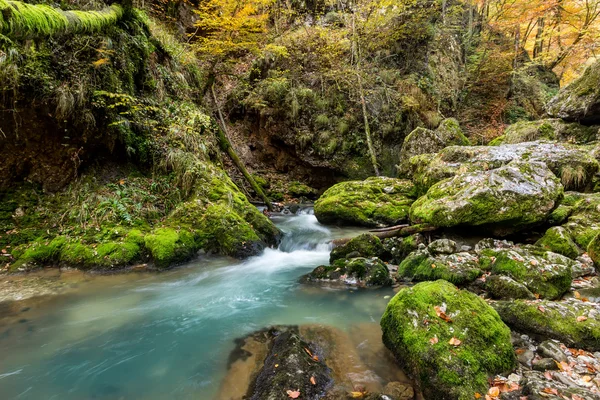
top-left (502, 118), bottom-right (600, 144)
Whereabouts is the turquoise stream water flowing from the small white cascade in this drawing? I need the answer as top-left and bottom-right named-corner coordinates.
top-left (0, 213), bottom-right (410, 400)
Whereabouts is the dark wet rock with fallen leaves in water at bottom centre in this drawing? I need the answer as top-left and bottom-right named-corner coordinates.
top-left (249, 330), bottom-right (332, 400)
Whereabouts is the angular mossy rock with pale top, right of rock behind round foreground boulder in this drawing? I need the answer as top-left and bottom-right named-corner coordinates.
top-left (491, 246), bottom-right (577, 300)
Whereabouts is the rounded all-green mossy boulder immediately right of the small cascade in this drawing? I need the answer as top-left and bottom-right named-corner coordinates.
top-left (315, 177), bottom-right (415, 227)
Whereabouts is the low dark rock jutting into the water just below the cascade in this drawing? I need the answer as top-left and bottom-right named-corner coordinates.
top-left (303, 257), bottom-right (393, 287)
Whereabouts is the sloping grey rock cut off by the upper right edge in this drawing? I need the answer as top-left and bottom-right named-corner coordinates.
top-left (547, 62), bottom-right (600, 124)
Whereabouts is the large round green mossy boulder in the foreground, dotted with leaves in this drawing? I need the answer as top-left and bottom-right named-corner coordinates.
top-left (381, 281), bottom-right (515, 400)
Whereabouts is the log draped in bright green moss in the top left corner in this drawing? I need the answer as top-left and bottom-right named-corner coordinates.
top-left (0, 0), bottom-right (124, 38)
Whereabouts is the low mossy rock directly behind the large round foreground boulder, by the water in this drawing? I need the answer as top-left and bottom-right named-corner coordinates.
top-left (398, 250), bottom-right (483, 285)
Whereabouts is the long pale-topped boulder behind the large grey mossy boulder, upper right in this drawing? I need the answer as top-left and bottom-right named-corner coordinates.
top-left (410, 142), bottom-right (600, 193)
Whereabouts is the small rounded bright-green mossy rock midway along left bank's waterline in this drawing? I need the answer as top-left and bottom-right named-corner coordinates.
top-left (145, 228), bottom-right (199, 268)
